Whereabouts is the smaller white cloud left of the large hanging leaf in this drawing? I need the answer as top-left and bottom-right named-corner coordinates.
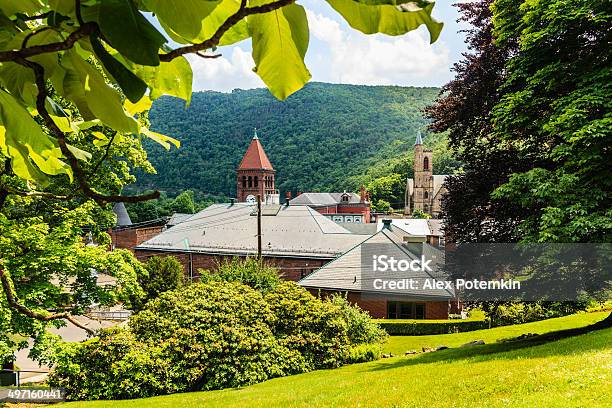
top-left (188, 47), bottom-right (264, 92)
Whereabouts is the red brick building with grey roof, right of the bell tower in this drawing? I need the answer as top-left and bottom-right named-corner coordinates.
top-left (288, 187), bottom-right (371, 223)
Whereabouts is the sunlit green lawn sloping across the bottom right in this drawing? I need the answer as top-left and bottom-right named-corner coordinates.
top-left (57, 313), bottom-right (612, 408)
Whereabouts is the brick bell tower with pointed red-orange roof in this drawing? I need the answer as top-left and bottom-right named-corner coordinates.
top-left (236, 129), bottom-right (278, 203)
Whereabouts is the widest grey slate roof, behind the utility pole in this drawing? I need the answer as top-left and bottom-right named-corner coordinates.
top-left (136, 203), bottom-right (370, 259)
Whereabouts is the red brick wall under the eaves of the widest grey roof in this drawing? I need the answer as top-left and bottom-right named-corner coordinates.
top-left (135, 249), bottom-right (331, 281)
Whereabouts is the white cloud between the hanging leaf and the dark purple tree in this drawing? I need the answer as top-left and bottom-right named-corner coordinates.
top-left (307, 11), bottom-right (450, 85)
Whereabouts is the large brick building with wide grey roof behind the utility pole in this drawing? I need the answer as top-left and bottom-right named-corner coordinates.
top-left (134, 203), bottom-right (370, 281)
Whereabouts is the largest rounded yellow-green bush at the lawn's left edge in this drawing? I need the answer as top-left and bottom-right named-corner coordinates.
top-left (49, 281), bottom-right (382, 399)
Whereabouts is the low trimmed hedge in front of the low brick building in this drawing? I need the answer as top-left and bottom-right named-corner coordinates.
top-left (376, 319), bottom-right (489, 336)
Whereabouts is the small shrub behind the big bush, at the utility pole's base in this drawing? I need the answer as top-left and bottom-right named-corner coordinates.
top-left (198, 258), bottom-right (281, 293)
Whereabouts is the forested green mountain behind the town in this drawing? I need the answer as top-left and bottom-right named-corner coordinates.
top-left (137, 83), bottom-right (453, 201)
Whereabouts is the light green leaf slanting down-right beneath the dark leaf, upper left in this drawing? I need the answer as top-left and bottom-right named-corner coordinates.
top-left (61, 49), bottom-right (138, 133)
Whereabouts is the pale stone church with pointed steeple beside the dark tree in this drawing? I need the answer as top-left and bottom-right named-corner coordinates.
top-left (404, 132), bottom-right (447, 218)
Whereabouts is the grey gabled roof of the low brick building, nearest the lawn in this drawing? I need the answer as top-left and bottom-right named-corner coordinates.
top-left (298, 229), bottom-right (454, 300)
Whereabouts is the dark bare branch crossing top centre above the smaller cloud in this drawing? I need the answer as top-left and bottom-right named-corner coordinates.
top-left (159, 0), bottom-right (295, 62)
